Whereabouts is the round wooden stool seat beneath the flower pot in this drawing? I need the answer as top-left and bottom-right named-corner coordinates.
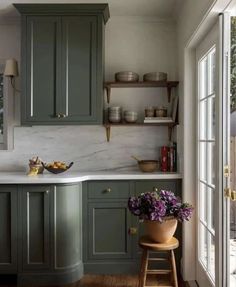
top-left (139, 236), bottom-right (179, 251)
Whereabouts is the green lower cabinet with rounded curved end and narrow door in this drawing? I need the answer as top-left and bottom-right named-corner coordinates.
top-left (18, 184), bottom-right (83, 285)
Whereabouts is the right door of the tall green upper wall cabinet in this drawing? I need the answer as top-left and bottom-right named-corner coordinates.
top-left (61, 16), bottom-right (101, 122)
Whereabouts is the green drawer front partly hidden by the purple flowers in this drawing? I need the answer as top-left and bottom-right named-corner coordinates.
top-left (135, 180), bottom-right (178, 195)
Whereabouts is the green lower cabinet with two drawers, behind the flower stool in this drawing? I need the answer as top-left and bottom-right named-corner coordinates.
top-left (83, 180), bottom-right (182, 274)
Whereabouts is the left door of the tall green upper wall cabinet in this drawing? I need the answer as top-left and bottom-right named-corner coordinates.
top-left (22, 16), bottom-right (61, 124)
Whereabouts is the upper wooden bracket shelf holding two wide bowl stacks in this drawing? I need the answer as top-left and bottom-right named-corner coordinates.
top-left (104, 81), bottom-right (179, 103)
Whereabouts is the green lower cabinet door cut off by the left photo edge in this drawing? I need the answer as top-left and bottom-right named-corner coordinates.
top-left (0, 185), bottom-right (17, 273)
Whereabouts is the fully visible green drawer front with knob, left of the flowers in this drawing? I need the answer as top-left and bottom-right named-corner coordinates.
top-left (88, 181), bottom-right (130, 199)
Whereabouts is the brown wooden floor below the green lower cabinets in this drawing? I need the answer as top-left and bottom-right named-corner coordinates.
top-left (0, 275), bottom-right (188, 287)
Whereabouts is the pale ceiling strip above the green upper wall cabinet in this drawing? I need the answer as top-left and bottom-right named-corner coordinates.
top-left (0, 0), bottom-right (184, 18)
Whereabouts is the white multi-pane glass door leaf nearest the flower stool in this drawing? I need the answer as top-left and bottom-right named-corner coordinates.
top-left (196, 23), bottom-right (222, 287)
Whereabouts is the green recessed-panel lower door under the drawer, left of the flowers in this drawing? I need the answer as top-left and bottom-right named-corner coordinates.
top-left (88, 202), bottom-right (131, 259)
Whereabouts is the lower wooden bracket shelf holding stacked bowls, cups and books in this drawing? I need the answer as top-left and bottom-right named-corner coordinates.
top-left (104, 122), bottom-right (178, 142)
